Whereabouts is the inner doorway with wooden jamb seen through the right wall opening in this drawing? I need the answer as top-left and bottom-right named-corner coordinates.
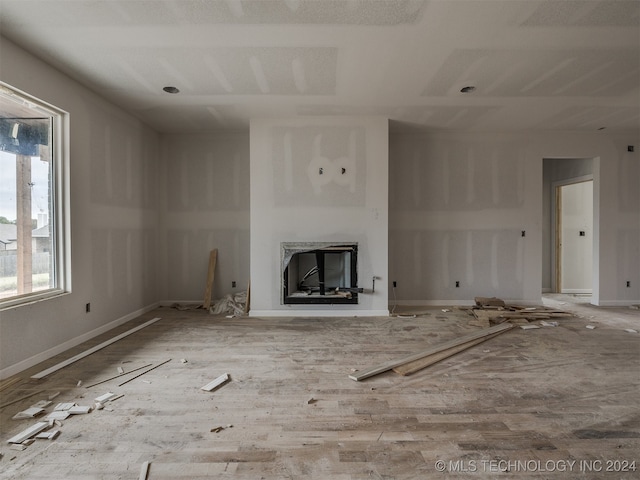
top-left (555, 179), bottom-right (594, 296)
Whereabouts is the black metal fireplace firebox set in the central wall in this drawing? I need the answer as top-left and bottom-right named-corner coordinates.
top-left (282, 243), bottom-right (363, 305)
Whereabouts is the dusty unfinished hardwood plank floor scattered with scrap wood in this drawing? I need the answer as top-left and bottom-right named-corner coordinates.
top-left (0, 299), bottom-right (640, 480)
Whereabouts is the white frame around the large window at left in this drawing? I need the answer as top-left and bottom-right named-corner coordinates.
top-left (0, 81), bottom-right (71, 311)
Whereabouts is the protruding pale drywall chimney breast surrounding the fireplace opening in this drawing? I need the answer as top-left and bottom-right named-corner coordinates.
top-left (250, 117), bottom-right (388, 315)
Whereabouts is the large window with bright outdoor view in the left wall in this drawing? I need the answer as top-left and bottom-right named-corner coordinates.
top-left (0, 83), bottom-right (69, 308)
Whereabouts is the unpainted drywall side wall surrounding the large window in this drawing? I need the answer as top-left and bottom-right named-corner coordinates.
top-left (0, 37), bottom-right (159, 377)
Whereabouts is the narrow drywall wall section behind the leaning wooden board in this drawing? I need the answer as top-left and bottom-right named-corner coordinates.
top-left (161, 132), bottom-right (249, 302)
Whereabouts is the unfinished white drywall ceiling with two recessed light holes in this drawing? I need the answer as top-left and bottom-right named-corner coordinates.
top-left (0, 0), bottom-right (640, 132)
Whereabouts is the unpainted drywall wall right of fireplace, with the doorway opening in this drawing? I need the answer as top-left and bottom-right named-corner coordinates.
top-left (389, 132), bottom-right (640, 305)
